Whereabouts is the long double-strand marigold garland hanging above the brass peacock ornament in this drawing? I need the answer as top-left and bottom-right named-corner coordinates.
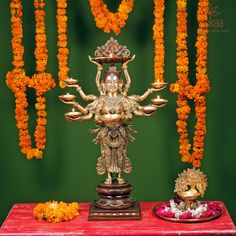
top-left (170, 0), bottom-right (210, 167)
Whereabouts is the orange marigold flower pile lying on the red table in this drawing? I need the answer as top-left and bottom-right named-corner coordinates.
top-left (33, 201), bottom-right (79, 223)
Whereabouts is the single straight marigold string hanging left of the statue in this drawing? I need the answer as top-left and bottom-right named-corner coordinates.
top-left (56, 0), bottom-right (69, 88)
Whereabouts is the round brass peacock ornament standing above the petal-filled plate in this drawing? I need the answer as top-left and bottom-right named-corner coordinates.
top-left (174, 168), bottom-right (207, 200)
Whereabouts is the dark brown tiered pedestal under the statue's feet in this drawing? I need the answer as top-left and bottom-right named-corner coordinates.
top-left (88, 182), bottom-right (141, 221)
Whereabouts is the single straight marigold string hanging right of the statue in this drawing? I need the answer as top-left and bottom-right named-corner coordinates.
top-left (153, 0), bottom-right (165, 82)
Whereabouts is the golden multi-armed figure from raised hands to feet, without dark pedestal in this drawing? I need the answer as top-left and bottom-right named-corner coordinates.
top-left (58, 39), bottom-right (167, 184)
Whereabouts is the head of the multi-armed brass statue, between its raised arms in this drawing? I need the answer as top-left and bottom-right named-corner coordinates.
top-left (102, 66), bottom-right (123, 93)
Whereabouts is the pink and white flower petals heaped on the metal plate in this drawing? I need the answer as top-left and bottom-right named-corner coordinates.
top-left (154, 198), bottom-right (220, 219)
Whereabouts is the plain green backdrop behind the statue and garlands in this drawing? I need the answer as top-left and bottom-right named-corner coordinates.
top-left (0, 0), bottom-right (236, 225)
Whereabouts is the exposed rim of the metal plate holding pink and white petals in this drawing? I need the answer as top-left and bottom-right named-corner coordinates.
top-left (152, 203), bottom-right (222, 223)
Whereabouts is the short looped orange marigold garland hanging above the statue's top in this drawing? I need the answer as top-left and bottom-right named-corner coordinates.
top-left (89, 0), bottom-right (134, 35)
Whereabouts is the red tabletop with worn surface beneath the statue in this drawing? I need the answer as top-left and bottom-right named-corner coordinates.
top-left (0, 202), bottom-right (236, 236)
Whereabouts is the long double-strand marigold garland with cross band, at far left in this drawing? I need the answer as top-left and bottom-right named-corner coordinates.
top-left (6, 0), bottom-right (55, 159)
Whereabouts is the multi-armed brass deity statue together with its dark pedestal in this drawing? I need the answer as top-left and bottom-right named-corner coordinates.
top-left (60, 38), bottom-right (167, 218)
